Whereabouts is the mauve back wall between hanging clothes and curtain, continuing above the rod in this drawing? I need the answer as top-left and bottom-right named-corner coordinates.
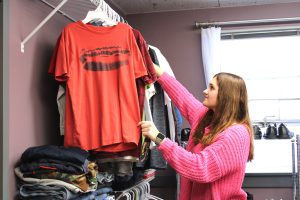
top-left (126, 3), bottom-right (300, 127)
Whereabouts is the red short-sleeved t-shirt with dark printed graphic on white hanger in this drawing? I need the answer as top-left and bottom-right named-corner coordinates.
top-left (49, 21), bottom-right (147, 152)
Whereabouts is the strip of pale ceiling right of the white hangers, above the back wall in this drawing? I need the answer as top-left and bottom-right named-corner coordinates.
top-left (106, 0), bottom-right (300, 15)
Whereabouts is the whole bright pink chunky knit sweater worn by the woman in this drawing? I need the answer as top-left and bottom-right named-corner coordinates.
top-left (158, 73), bottom-right (250, 200)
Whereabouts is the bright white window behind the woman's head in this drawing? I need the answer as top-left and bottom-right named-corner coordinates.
top-left (221, 35), bottom-right (300, 123)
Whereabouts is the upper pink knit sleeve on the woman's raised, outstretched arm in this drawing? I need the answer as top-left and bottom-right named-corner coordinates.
top-left (158, 72), bottom-right (208, 126)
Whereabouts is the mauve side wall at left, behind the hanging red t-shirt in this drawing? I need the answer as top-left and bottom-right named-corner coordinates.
top-left (6, 0), bottom-right (69, 199)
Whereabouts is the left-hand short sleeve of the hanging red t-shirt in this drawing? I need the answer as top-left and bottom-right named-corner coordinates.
top-left (48, 30), bottom-right (69, 81)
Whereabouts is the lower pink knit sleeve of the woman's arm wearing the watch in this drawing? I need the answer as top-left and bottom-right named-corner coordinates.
top-left (158, 125), bottom-right (250, 183)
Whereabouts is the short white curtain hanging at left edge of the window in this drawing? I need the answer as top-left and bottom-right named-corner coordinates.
top-left (201, 27), bottom-right (221, 86)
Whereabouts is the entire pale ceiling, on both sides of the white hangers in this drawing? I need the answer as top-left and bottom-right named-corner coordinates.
top-left (41, 0), bottom-right (300, 19)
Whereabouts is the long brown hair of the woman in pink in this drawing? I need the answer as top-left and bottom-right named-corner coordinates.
top-left (193, 72), bottom-right (254, 161)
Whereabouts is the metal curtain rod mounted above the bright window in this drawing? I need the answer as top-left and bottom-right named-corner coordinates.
top-left (195, 17), bottom-right (300, 28)
